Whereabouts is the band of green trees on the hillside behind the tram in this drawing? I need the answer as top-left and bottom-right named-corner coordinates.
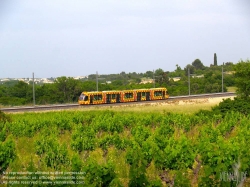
top-left (0, 59), bottom-right (244, 106)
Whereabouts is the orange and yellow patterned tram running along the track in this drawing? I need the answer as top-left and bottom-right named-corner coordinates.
top-left (78, 88), bottom-right (169, 105)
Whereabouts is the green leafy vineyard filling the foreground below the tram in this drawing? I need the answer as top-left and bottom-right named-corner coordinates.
top-left (0, 106), bottom-right (250, 187)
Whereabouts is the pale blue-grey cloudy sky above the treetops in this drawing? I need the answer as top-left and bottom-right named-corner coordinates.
top-left (0, 0), bottom-right (250, 78)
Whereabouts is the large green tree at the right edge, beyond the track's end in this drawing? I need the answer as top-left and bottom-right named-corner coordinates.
top-left (235, 60), bottom-right (250, 99)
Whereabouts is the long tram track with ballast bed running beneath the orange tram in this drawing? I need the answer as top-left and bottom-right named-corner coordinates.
top-left (0, 92), bottom-right (236, 113)
